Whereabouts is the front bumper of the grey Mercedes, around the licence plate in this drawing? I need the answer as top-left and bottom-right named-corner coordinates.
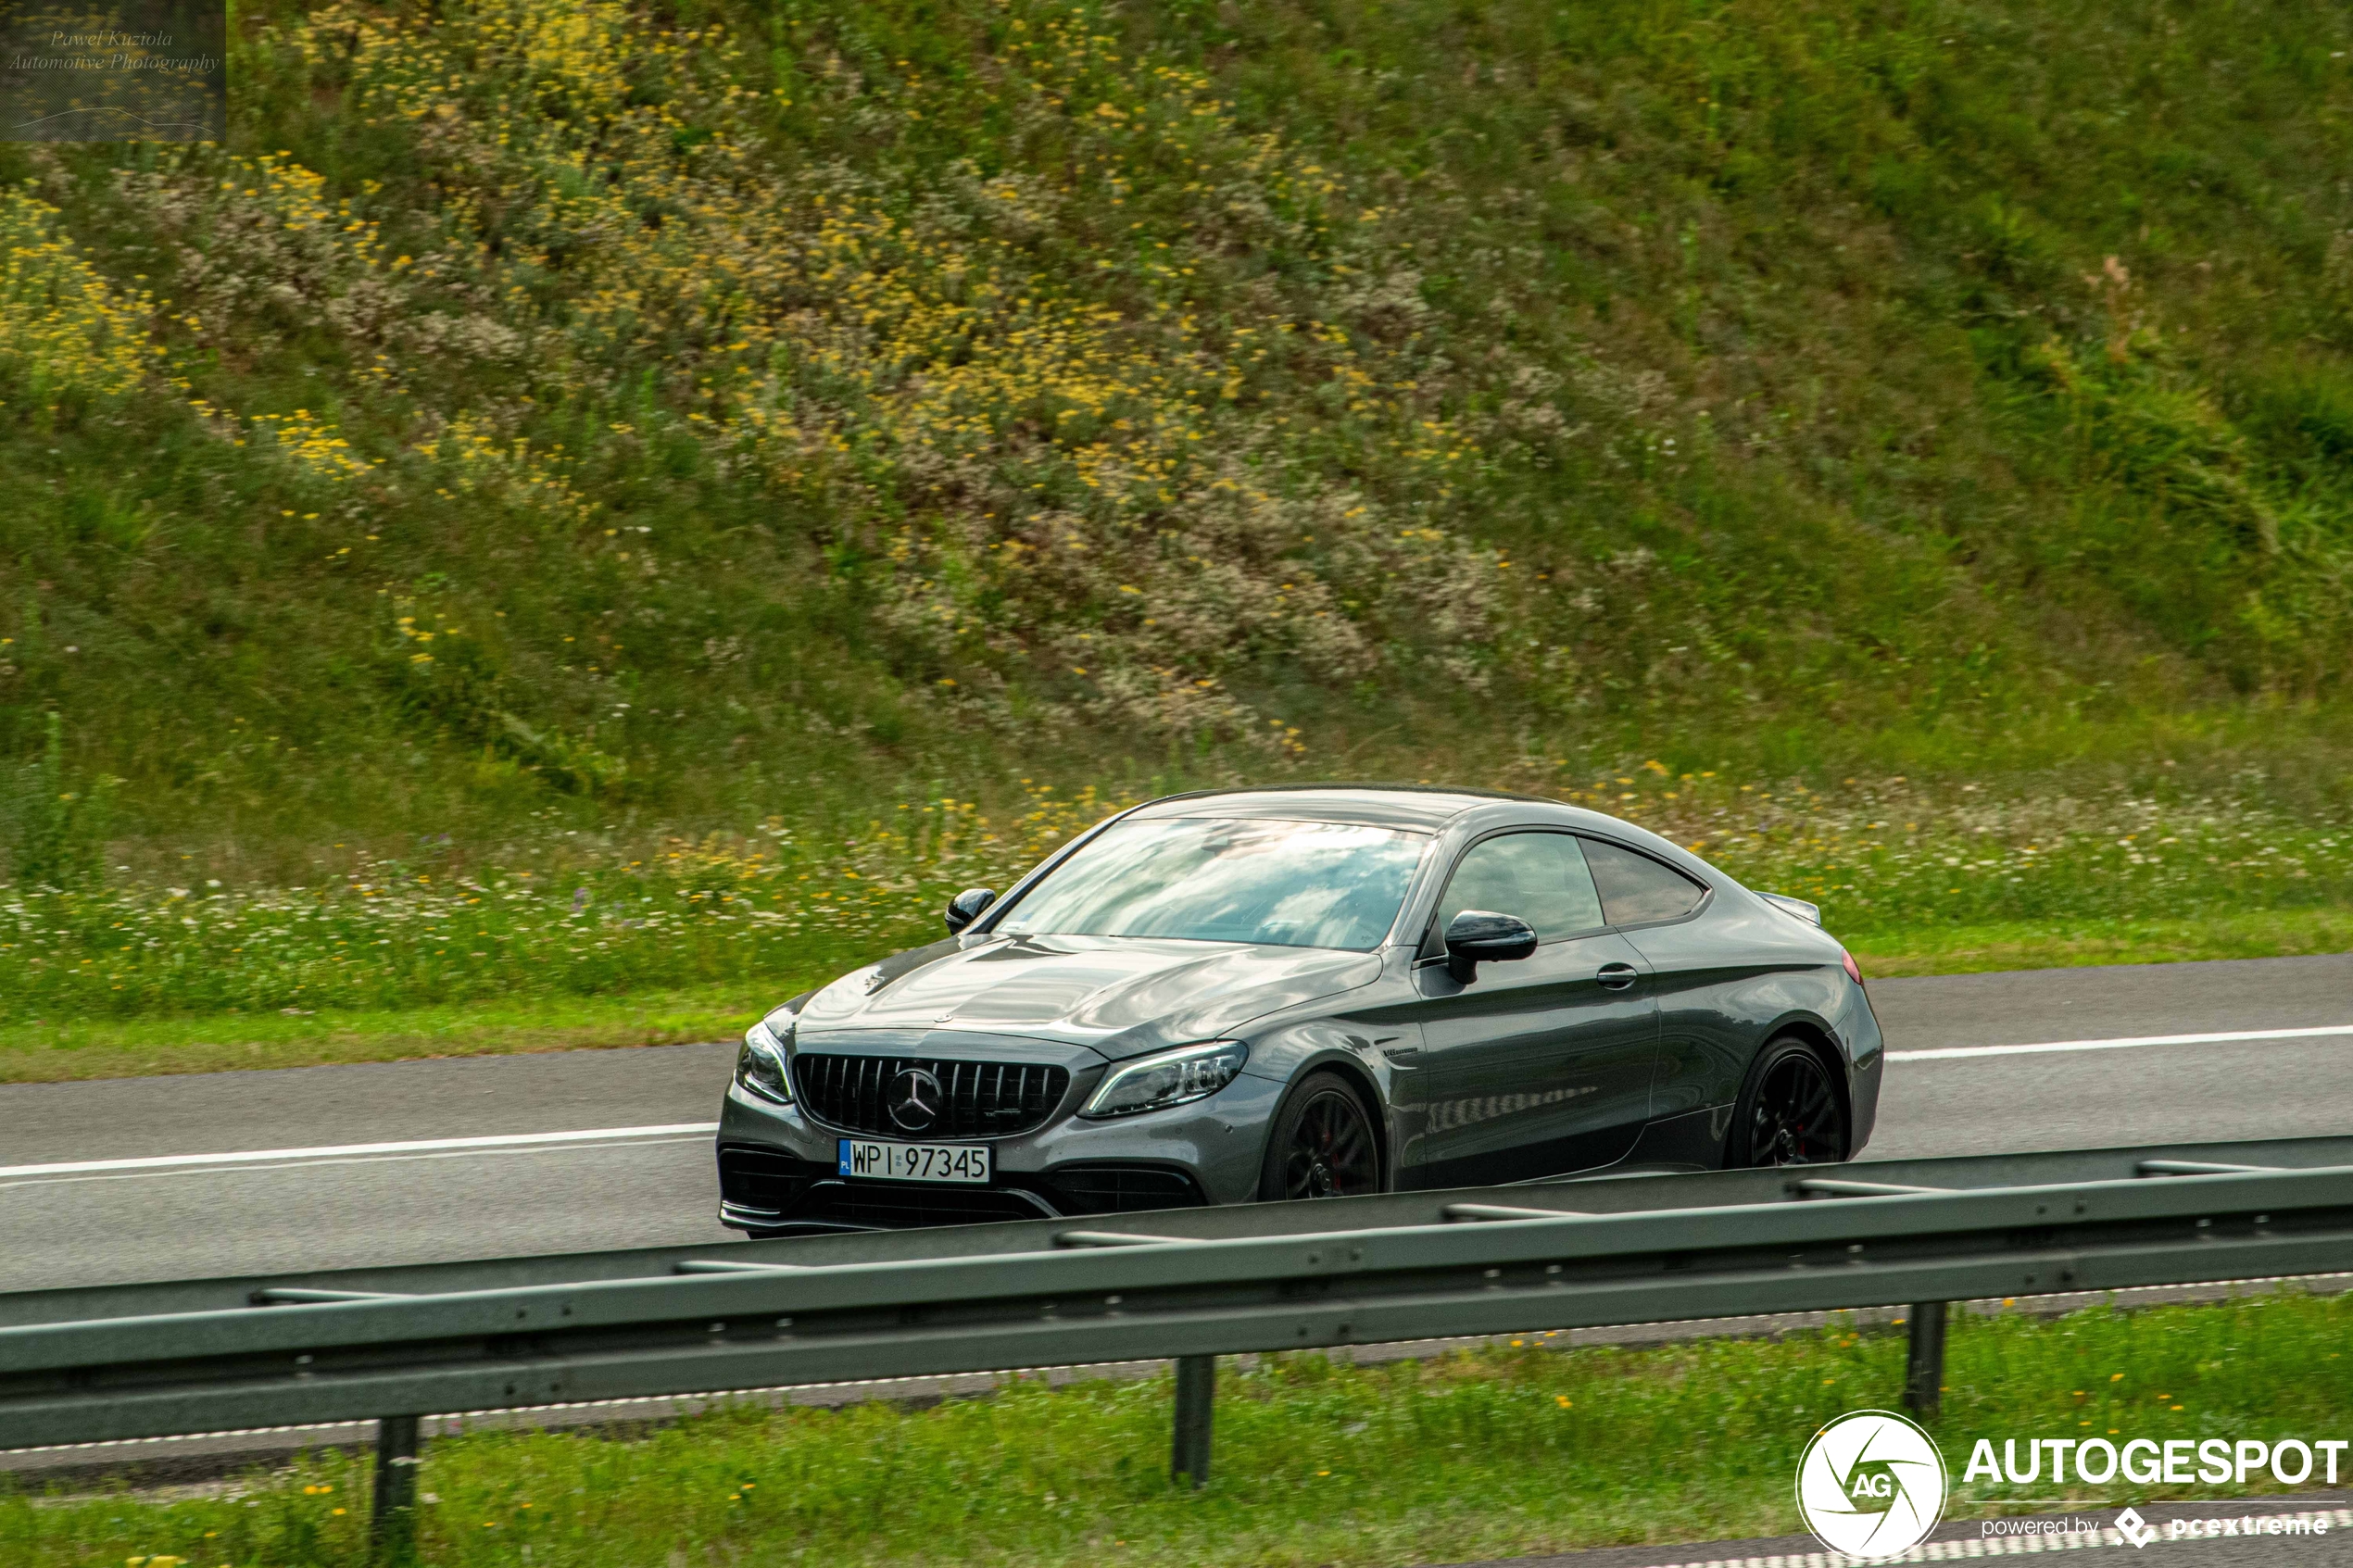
top-left (718, 1072), bottom-right (1282, 1232)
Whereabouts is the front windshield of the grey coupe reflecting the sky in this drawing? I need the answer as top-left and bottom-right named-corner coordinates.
top-left (995, 816), bottom-right (1428, 952)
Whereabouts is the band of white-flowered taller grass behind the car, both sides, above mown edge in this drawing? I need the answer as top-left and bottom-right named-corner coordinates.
top-left (0, 761), bottom-right (2353, 1025)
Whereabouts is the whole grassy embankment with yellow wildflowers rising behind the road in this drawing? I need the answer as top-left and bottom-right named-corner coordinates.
top-left (0, 0), bottom-right (2353, 1077)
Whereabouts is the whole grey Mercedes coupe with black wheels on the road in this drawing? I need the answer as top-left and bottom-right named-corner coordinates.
top-left (718, 785), bottom-right (1885, 1235)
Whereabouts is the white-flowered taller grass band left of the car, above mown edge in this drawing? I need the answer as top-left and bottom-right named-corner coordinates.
top-left (0, 787), bottom-right (1103, 1022)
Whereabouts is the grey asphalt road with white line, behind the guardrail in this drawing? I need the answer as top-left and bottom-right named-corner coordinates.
top-left (0, 955), bottom-right (2353, 1298)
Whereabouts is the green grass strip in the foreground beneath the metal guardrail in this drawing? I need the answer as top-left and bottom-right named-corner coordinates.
top-left (0, 1296), bottom-right (2353, 1568)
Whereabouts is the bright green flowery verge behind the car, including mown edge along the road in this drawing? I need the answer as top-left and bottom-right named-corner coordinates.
top-left (0, 761), bottom-right (2353, 1082)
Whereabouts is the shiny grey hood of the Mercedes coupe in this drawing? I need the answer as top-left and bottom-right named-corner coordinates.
top-left (796, 935), bottom-right (1381, 1060)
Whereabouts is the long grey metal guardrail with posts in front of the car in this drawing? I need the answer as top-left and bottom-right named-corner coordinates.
top-left (13, 1138), bottom-right (2353, 1551)
